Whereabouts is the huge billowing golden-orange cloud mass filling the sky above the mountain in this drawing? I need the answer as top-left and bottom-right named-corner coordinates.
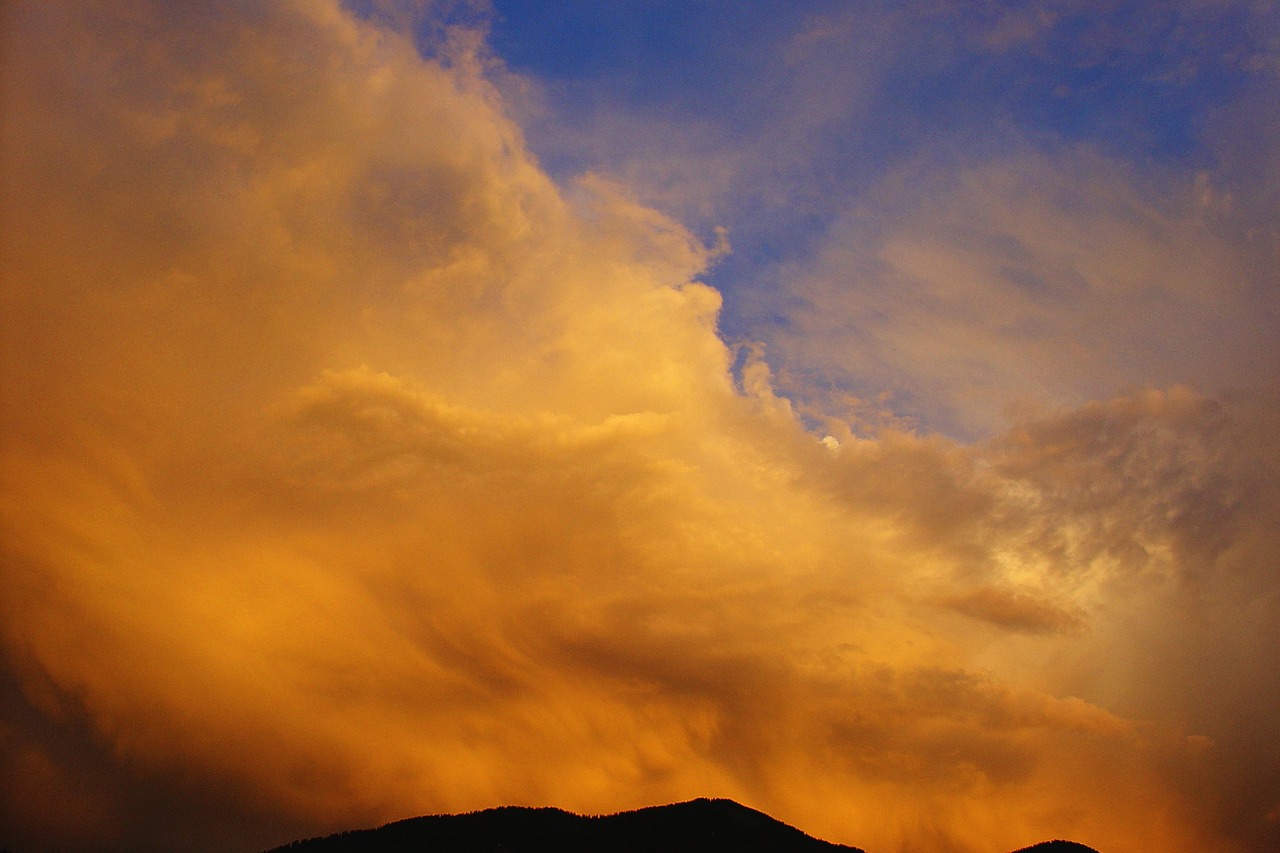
top-left (0, 0), bottom-right (1280, 853)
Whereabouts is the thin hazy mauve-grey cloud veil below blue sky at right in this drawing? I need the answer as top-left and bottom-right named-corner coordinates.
top-left (771, 145), bottom-right (1275, 434)
